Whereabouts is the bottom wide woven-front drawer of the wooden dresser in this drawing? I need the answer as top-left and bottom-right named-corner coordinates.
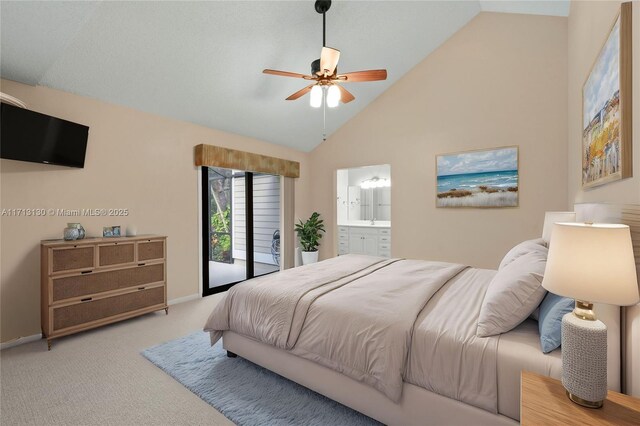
top-left (51, 286), bottom-right (164, 331)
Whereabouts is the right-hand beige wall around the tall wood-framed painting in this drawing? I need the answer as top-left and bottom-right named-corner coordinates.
top-left (568, 0), bottom-right (640, 204)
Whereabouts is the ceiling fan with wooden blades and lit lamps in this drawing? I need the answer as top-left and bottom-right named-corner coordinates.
top-left (262, 0), bottom-right (387, 108)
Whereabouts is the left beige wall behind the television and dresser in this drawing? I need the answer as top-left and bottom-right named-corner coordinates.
top-left (0, 80), bottom-right (309, 342)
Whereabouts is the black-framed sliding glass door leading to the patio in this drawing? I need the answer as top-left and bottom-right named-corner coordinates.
top-left (202, 167), bottom-right (280, 296)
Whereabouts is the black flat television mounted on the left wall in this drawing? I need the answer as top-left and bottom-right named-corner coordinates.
top-left (0, 104), bottom-right (89, 168)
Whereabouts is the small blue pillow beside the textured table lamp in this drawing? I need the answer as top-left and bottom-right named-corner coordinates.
top-left (538, 292), bottom-right (575, 354)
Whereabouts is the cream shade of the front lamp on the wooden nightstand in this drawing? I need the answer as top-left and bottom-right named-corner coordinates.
top-left (542, 223), bottom-right (640, 306)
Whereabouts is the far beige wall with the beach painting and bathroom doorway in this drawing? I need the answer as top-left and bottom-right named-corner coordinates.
top-left (311, 13), bottom-right (567, 268)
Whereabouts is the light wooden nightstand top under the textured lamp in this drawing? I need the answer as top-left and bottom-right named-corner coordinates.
top-left (520, 371), bottom-right (640, 425)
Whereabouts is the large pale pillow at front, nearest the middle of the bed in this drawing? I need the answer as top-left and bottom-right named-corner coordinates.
top-left (476, 245), bottom-right (548, 337)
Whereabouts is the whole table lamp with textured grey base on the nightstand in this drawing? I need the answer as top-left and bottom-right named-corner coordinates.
top-left (542, 223), bottom-right (640, 408)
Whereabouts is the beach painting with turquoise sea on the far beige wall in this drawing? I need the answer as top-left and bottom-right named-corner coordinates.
top-left (436, 146), bottom-right (518, 207)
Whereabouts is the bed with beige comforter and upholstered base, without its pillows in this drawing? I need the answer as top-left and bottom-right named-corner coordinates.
top-left (205, 202), bottom-right (636, 424)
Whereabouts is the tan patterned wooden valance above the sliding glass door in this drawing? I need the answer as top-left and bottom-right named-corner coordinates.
top-left (196, 144), bottom-right (300, 178)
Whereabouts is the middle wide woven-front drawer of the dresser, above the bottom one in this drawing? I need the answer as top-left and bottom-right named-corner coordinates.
top-left (51, 264), bottom-right (165, 302)
